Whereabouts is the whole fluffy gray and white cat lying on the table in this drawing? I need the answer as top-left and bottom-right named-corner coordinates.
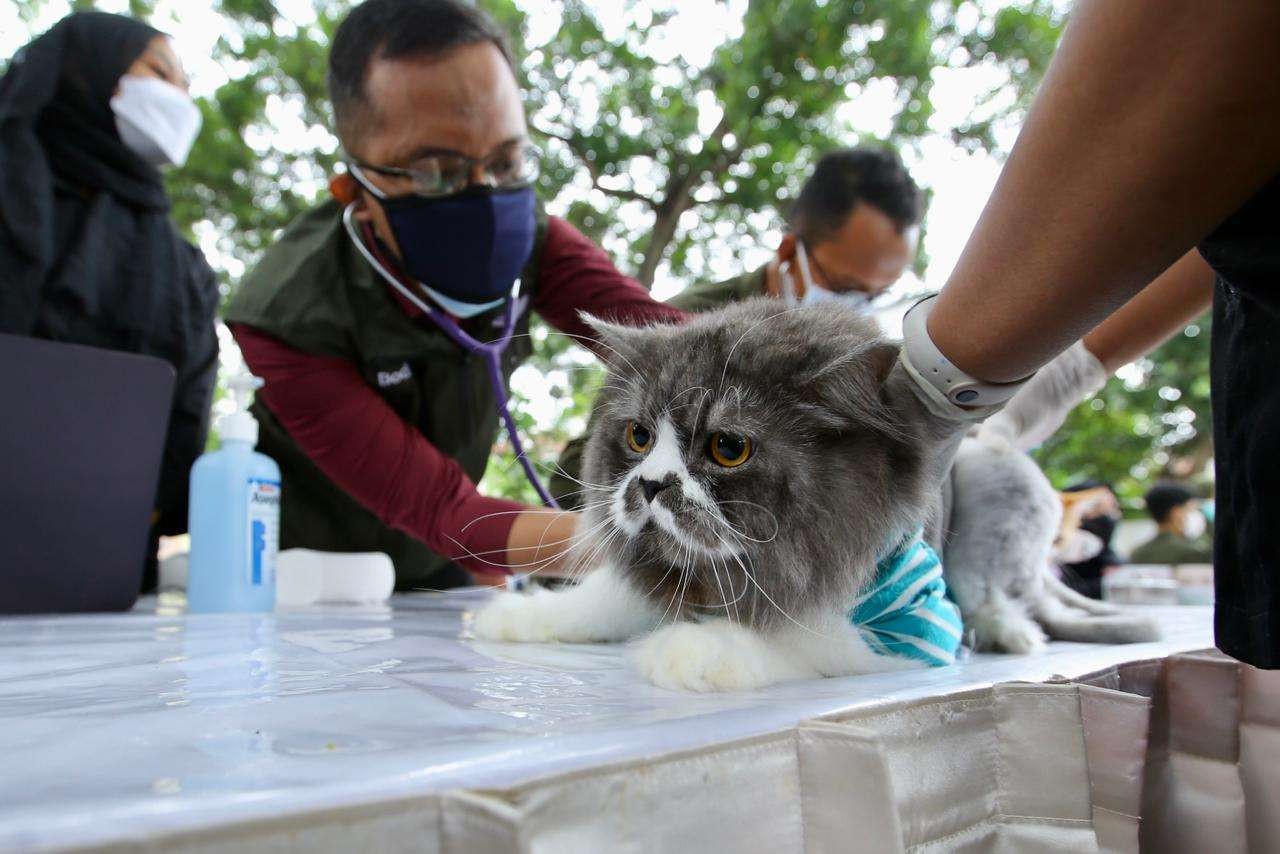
top-left (474, 300), bottom-right (1157, 691)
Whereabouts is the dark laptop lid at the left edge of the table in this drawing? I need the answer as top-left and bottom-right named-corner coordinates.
top-left (0, 335), bottom-right (174, 613)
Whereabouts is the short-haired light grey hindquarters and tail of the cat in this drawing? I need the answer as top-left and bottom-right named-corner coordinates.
top-left (942, 437), bottom-right (1160, 653)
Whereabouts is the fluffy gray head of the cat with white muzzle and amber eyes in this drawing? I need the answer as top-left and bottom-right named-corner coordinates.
top-left (584, 300), bottom-right (923, 622)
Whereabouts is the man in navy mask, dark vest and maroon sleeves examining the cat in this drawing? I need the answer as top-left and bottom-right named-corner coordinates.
top-left (227, 0), bottom-right (684, 589)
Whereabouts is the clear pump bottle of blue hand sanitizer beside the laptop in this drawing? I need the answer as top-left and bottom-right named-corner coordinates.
top-left (187, 374), bottom-right (280, 613)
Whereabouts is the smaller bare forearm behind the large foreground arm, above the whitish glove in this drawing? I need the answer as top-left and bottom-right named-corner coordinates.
top-left (1084, 250), bottom-right (1213, 374)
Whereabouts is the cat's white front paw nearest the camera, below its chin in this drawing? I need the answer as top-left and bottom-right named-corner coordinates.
top-left (632, 621), bottom-right (804, 691)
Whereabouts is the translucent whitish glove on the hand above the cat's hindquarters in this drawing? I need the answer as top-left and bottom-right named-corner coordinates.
top-left (978, 341), bottom-right (1107, 451)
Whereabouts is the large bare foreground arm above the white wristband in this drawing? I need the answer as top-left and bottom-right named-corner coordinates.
top-left (928, 0), bottom-right (1280, 382)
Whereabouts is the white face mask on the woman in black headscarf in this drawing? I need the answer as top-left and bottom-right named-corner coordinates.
top-left (111, 74), bottom-right (201, 166)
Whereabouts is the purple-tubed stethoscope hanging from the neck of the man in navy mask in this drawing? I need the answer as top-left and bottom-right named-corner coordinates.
top-left (342, 202), bottom-right (559, 510)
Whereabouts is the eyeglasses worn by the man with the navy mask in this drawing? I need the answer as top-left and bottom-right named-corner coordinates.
top-left (347, 142), bottom-right (543, 198)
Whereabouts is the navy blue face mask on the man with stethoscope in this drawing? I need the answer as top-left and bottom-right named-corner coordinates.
top-left (380, 187), bottom-right (535, 318)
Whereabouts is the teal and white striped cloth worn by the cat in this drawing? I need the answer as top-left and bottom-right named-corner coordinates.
top-left (849, 530), bottom-right (961, 667)
